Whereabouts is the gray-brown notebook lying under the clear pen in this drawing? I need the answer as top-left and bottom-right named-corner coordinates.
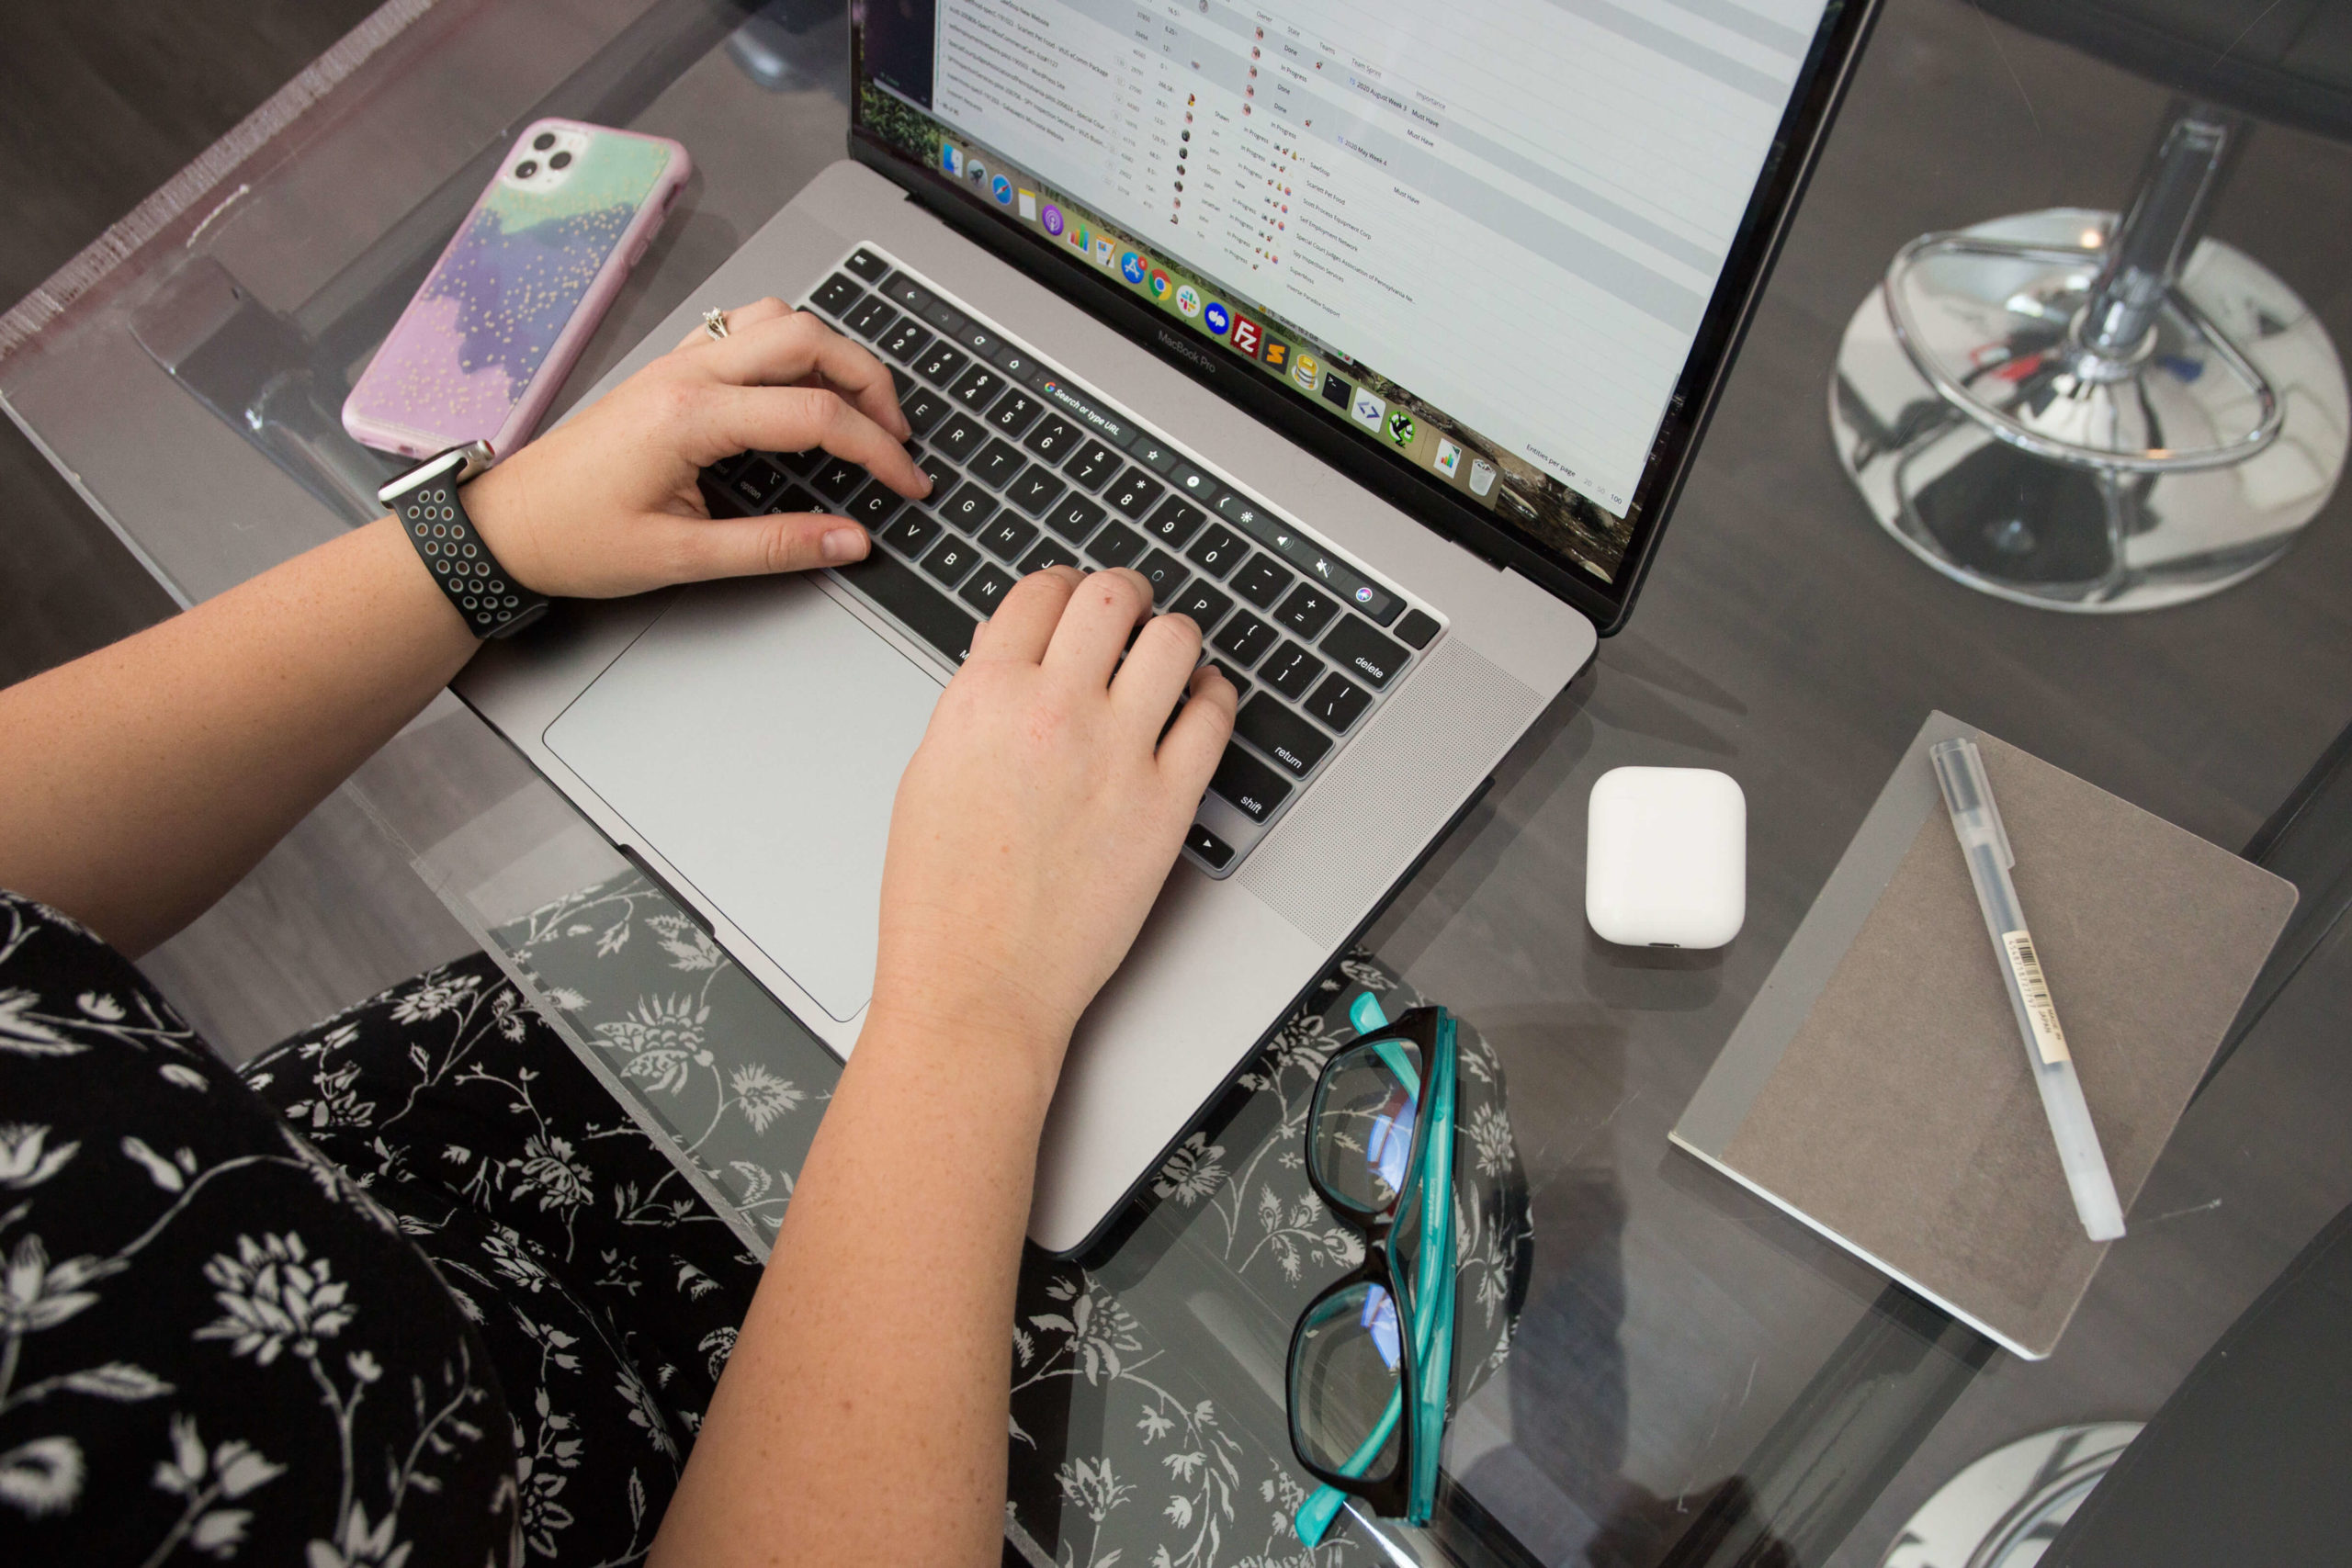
top-left (1672, 712), bottom-right (2296, 1359)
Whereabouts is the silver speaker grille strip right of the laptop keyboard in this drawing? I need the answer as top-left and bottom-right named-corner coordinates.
top-left (1238, 637), bottom-right (1543, 947)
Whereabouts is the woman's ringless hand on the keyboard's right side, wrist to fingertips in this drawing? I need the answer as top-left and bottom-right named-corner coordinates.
top-left (873, 567), bottom-right (1235, 1096)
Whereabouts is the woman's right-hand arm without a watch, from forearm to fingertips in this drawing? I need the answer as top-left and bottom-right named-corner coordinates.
top-left (647, 567), bottom-right (1235, 1568)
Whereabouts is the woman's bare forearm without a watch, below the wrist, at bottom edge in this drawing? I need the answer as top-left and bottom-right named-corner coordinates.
top-left (651, 1021), bottom-right (1058, 1568)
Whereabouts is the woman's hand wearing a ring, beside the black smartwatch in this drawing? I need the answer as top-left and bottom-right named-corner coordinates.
top-left (466, 299), bottom-right (932, 600)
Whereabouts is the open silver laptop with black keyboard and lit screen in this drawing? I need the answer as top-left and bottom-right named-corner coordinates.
top-left (458, 0), bottom-right (1872, 1256)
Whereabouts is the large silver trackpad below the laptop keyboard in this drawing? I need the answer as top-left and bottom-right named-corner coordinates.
top-left (546, 579), bottom-right (941, 1022)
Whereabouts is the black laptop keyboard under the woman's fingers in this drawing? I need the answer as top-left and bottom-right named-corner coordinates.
top-left (701, 244), bottom-right (1440, 877)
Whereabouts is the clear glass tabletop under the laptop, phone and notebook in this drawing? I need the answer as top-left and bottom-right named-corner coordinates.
top-left (0, 0), bottom-right (2352, 1568)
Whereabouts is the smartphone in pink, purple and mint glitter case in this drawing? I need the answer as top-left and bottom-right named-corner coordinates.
top-left (344, 120), bottom-right (694, 458)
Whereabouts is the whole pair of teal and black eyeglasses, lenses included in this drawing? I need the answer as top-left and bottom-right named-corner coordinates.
top-left (1286, 995), bottom-right (1456, 1547)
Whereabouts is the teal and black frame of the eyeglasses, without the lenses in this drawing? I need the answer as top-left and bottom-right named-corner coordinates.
top-left (1284, 992), bottom-right (1458, 1547)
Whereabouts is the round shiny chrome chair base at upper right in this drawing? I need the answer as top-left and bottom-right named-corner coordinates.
top-left (1830, 207), bottom-right (2352, 614)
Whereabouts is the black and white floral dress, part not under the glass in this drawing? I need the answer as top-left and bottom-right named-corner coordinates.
top-left (0, 894), bottom-right (760, 1568)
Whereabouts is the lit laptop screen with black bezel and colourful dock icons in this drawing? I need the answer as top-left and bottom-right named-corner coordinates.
top-left (852, 0), bottom-right (1858, 625)
